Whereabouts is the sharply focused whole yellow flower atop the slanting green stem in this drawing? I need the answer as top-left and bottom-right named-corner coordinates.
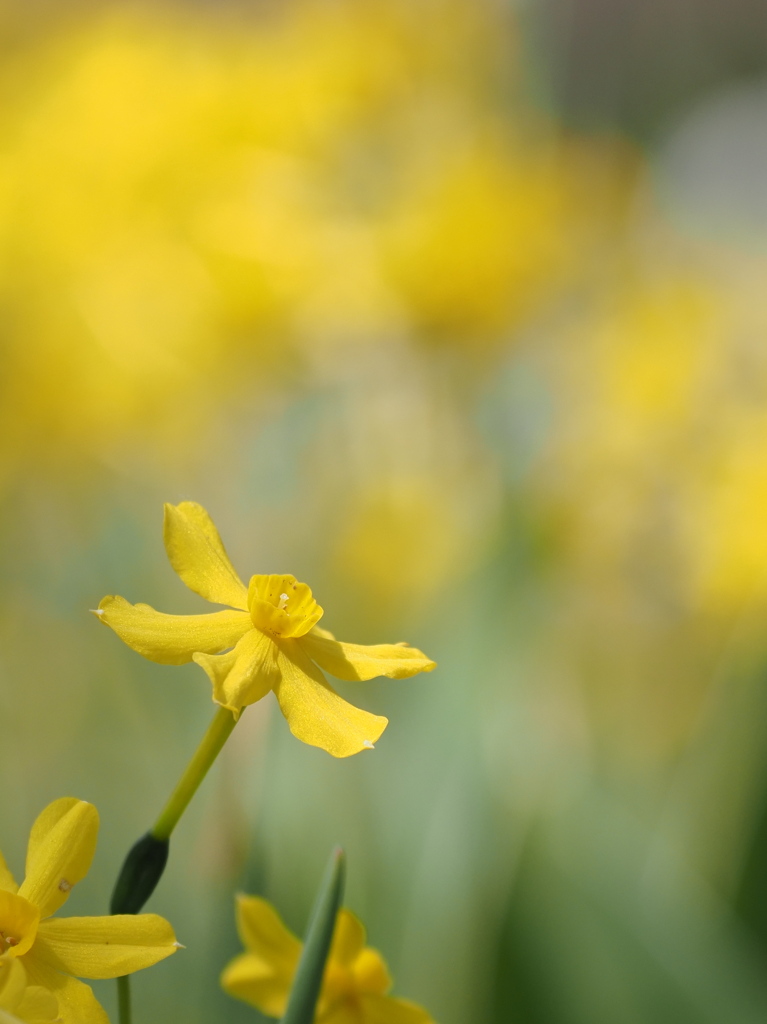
top-left (96, 502), bottom-right (434, 758)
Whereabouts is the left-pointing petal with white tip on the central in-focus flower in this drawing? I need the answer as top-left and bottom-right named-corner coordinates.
top-left (96, 596), bottom-right (253, 665)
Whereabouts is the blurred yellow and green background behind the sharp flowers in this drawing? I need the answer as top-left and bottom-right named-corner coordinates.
top-left (0, 0), bottom-right (767, 1024)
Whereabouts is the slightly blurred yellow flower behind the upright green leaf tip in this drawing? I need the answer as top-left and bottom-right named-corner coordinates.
top-left (221, 895), bottom-right (433, 1024)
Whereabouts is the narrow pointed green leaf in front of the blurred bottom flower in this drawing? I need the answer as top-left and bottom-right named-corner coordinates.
top-left (282, 848), bottom-right (345, 1024)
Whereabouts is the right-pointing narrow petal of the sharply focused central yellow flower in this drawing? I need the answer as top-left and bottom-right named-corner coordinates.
top-left (301, 631), bottom-right (436, 682)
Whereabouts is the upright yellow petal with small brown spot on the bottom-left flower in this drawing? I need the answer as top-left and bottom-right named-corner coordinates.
top-left (18, 797), bottom-right (98, 918)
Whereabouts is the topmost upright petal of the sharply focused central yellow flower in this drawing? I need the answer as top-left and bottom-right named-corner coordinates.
top-left (163, 502), bottom-right (248, 608)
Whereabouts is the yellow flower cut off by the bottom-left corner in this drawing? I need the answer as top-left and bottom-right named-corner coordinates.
top-left (0, 797), bottom-right (178, 1024)
